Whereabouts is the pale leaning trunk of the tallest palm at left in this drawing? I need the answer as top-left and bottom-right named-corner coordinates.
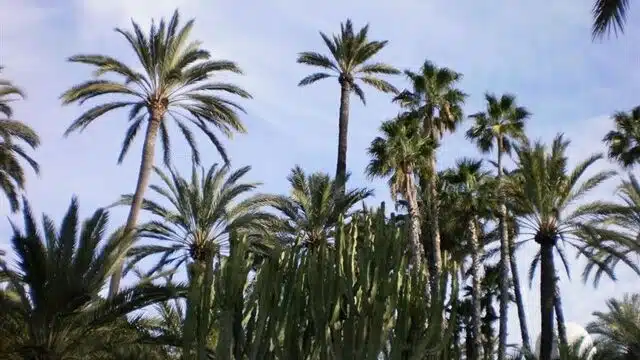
top-left (109, 116), bottom-right (164, 298)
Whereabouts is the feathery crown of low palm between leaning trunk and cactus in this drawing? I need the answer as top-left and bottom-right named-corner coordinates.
top-left (117, 164), bottom-right (275, 273)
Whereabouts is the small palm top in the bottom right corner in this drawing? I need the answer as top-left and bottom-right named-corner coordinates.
top-left (587, 294), bottom-right (640, 360)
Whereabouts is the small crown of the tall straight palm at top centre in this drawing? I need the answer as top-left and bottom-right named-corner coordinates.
top-left (298, 19), bottom-right (400, 103)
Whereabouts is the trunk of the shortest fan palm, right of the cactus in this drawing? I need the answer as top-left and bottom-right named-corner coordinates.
top-left (469, 219), bottom-right (482, 360)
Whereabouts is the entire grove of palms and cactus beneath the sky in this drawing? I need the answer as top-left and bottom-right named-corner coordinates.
top-left (0, 1), bottom-right (640, 360)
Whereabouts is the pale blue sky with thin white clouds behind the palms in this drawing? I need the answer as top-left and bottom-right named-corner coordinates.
top-left (0, 0), bottom-right (640, 343)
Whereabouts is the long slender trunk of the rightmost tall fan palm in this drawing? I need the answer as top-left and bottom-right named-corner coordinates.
top-left (498, 138), bottom-right (509, 360)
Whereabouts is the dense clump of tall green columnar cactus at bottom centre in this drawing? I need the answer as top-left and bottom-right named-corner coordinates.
top-left (200, 204), bottom-right (457, 360)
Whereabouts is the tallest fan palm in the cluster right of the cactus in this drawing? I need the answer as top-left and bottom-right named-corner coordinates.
top-left (394, 60), bottom-right (467, 300)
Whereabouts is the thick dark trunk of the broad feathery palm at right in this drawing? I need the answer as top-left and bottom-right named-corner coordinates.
top-left (540, 240), bottom-right (556, 360)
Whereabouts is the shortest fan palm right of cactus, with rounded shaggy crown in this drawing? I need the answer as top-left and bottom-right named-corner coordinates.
top-left (441, 158), bottom-right (493, 359)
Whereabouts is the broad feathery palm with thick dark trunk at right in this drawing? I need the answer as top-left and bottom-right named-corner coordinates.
top-left (505, 135), bottom-right (615, 360)
